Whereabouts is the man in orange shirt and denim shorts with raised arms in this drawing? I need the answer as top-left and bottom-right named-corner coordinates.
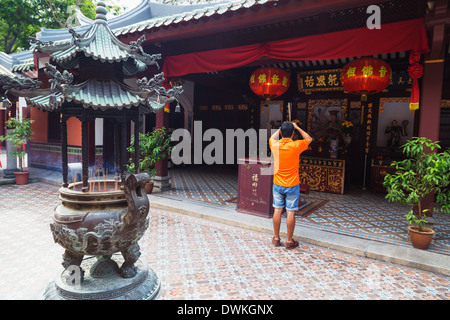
top-left (269, 122), bottom-right (312, 249)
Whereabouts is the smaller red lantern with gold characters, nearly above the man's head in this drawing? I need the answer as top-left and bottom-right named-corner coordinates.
top-left (250, 67), bottom-right (290, 100)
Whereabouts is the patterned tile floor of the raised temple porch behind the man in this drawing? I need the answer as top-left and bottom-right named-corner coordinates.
top-left (158, 167), bottom-right (450, 256)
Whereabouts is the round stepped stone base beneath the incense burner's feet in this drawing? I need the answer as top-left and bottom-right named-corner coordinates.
top-left (43, 255), bottom-right (161, 300)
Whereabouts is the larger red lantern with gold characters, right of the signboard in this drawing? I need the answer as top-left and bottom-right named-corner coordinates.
top-left (341, 58), bottom-right (392, 101)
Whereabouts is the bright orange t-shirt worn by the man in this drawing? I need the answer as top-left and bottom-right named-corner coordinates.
top-left (269, 138), bottom-right (309, 187)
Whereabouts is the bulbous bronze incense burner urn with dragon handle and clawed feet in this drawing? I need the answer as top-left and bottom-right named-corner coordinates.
top-left (50, 173), bottom-right (149, 278)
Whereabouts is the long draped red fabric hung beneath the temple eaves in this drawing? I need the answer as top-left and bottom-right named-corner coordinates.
top-left (162, 18), bottom-right (429, 78)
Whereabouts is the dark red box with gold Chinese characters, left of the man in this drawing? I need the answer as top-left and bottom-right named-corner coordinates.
top-left (236, 158), bottom-right (273, 218)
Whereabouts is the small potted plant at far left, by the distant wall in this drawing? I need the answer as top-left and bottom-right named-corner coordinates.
top-left (0, 117), bottom-right (33, 185)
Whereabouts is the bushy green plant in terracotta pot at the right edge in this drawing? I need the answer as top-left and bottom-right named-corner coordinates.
top-left (383, 137), bottom-right (450, 250)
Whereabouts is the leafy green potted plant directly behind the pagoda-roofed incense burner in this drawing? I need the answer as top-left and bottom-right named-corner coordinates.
top-left (127, 127), bottom-right (173, 194)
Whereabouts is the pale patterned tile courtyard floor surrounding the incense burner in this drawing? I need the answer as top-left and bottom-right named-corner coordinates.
top-left (0, 183), bottom-right (450, 300)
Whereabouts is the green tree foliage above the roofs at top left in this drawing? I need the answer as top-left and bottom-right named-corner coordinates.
top-left (0, 0), bottom-right (123, 53)
